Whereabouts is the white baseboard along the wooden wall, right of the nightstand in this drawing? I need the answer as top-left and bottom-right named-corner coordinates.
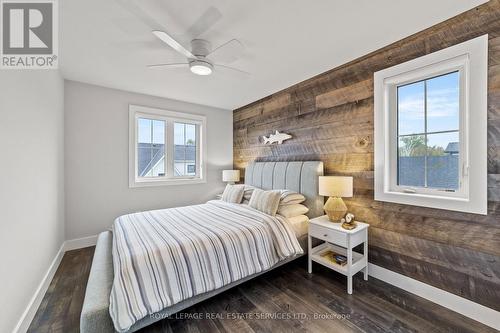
top-left (368, 264), bottom-right (500, 330)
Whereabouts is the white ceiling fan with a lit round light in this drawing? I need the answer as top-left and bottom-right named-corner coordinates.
top-left (148, 30), bottom-right (249, 75)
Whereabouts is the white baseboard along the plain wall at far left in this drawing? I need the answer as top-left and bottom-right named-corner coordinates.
top-left (13, 243), bottom-right (65, 333)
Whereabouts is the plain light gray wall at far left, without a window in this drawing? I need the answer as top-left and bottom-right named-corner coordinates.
top-left (0, 70), bottom-right (64, 332)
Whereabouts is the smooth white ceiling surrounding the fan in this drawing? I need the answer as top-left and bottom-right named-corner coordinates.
top-left (60, 0), bottom-right (486, 109)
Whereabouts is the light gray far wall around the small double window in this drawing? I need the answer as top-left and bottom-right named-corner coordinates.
top-left (65, 81), bottom-right (233, 239)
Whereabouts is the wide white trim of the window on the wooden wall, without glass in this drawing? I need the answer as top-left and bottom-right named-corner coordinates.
top-left (374, 35), bottom-right (488, 214)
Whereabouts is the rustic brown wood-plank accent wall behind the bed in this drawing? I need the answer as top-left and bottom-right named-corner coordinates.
top-left (234, 0), bottom-right (500, 310)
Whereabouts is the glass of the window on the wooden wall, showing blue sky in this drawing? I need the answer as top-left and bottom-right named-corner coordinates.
top-left (397, 71), bottom-right (460, 191)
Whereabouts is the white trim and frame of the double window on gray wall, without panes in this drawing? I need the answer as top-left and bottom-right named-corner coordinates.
top-left (129, 104), bottom-right (207, 188)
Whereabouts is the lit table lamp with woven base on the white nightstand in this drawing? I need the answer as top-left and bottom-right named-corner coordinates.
top-left (319, 176), bottom-right (352, 222)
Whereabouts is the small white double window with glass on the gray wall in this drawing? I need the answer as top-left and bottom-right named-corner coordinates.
top-left (129, 105), bottom-right (206, 187)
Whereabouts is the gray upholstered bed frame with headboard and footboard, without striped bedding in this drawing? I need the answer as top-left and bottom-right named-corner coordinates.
top-left (80, 161), bottom-right (323, 333)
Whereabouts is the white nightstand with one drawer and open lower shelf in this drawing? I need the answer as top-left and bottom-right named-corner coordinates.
top-left (308, 215), bottom-right (370, 294)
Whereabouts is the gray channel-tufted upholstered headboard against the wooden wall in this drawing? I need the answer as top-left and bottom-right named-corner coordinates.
top-left (245, 161), bottom-right (324, 218)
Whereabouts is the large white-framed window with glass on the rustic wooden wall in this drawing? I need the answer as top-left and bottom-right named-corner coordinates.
top-left (374, 36), bottom-right (488, 214)
